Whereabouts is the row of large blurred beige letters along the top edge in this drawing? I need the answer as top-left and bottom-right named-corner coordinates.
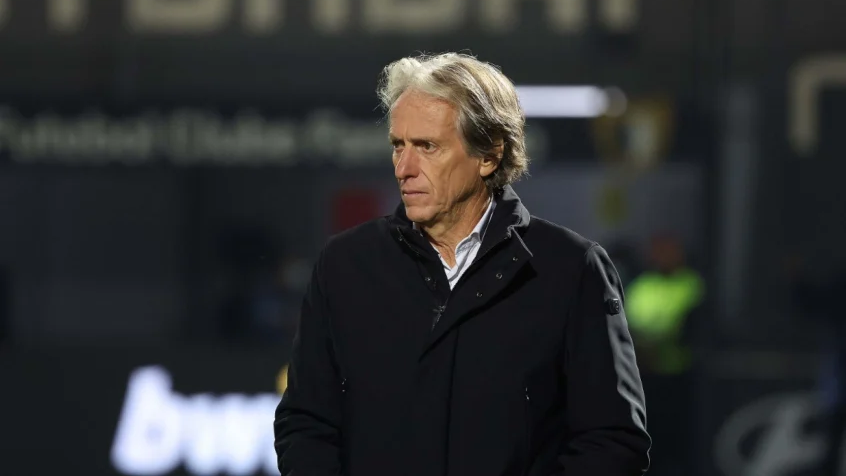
top-left (0, 0), bottom-right (640, 36)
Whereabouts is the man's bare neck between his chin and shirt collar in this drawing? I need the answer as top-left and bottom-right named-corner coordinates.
top-left (421, 188), bottom-right (492, 266)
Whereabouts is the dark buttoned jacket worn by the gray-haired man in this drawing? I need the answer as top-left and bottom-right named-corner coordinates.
top-left (274, 187), bottom-right (650, 476)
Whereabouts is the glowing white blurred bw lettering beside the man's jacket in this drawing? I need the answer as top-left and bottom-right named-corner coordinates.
top-left (112, 366), bottom-right (279, 476)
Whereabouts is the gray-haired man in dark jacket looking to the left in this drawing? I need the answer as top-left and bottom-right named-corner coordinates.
top-left (274, 54), bottom-right (650, 476)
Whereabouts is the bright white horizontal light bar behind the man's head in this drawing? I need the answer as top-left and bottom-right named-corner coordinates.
top-left (516, 86), bottom-right (627, 118)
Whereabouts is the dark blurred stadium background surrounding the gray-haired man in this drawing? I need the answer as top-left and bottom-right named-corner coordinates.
top-left (0, 0), bottom-right (846, 476)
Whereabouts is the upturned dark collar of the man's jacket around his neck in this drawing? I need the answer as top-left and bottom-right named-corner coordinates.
top-left (388, 185), bottom-right (531, 259)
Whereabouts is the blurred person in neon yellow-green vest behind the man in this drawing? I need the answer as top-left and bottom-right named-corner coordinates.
top-left (626, 234), bottom-right (704, 476)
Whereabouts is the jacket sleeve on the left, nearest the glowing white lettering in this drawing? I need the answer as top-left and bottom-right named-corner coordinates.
top-left (273, 251), bottom-right (342, 476)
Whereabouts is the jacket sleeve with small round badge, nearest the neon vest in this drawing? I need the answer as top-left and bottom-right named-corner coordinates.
top-left (559, 244), bottom-right (651, 476)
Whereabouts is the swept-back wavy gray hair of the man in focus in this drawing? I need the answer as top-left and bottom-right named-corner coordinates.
top-left (377, 53), bottom-right (529, 191)
